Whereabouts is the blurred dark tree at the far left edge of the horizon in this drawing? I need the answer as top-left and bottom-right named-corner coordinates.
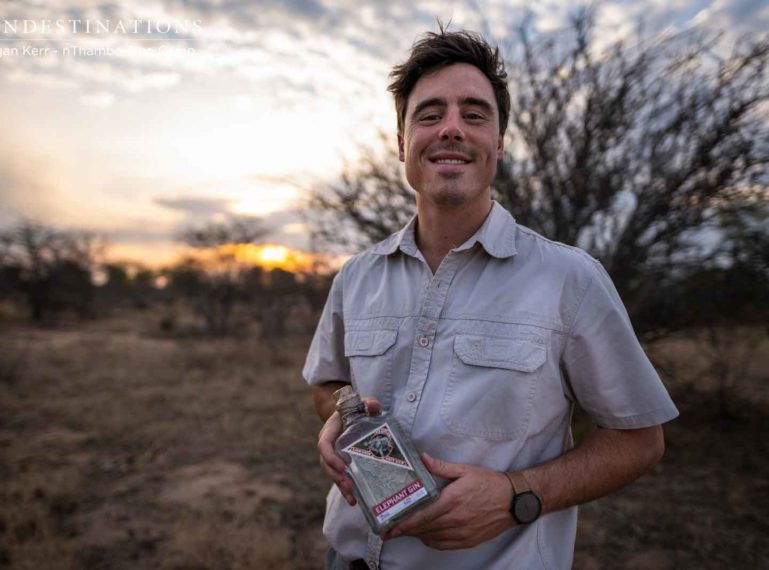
top-left (0, 221), bottom-right (105, 321)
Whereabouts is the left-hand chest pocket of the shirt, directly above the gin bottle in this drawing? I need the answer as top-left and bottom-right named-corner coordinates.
top-left (344, 330), bottom-right (398, 410)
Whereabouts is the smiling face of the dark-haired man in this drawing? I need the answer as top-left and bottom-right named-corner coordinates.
top-left (398, 63), bottom-right (503, 206)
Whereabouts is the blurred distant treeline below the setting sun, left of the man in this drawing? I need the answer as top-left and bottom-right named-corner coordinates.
top-left (0, 221), bottom-right (333, 336)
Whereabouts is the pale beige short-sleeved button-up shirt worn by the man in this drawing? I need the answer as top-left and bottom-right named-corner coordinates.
top-left (304, 203), bottom-right (678, 570)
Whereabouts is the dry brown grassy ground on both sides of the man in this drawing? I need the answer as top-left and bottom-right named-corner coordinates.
top-left (0, 310), bottom-right (769, 570)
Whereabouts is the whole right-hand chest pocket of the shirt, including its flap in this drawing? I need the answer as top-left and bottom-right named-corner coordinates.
top-left (441, 334), bottom-right (547, 441)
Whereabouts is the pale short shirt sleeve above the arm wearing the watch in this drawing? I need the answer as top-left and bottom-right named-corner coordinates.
top-left (563, 263), bottom-right (678, 429)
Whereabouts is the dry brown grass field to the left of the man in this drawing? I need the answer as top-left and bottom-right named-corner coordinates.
top-left (0, 317), bottom-right (326, 570)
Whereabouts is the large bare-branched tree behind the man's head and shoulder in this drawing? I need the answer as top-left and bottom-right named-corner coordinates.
top-left (309, 10), bottom-right (769, 334)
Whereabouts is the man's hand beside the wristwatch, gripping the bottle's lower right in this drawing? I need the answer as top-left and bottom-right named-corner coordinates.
top-left (383, 453), bottom-right (515, 550)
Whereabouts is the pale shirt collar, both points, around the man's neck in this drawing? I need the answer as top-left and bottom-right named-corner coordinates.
top-left (371, 201), bottom-right (517, 259)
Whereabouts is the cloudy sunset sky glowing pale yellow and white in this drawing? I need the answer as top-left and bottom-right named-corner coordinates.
top-left (0, 0), bottom-right (769, 265)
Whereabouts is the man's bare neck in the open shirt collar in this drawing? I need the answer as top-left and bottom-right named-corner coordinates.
top-left (416, 200), bottom-right (492, 274)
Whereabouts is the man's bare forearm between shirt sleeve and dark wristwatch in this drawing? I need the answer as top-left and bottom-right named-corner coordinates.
top-left (523, 426), bottom-right (665, 514)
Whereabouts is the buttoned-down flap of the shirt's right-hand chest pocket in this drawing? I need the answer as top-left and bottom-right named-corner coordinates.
top-left (454, 335), bottom-right (547, 372)
